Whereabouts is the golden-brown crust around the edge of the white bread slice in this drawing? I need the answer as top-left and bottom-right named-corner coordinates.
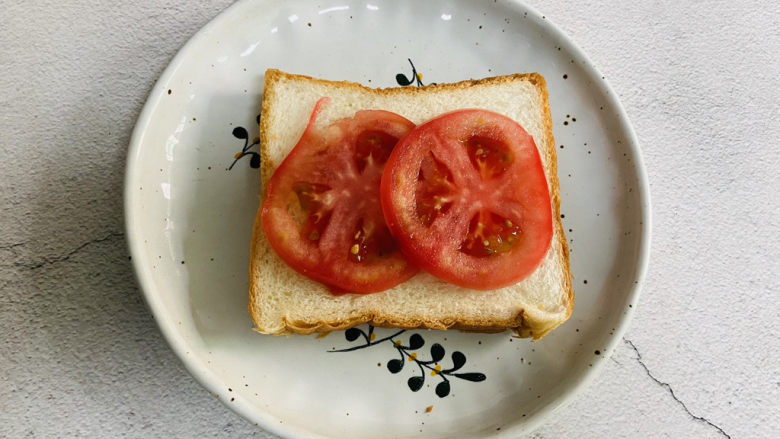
top-left (249, 69), bottom-right (575, 340)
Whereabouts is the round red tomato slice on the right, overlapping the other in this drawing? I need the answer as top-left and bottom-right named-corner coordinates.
top-left (381, 110), bottom-right (553, 290)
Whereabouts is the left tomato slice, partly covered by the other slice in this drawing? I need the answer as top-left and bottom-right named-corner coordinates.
top-left (262, 98), bottom-right (418, 294)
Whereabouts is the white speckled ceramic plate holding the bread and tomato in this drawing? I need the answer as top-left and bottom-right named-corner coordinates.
top-left (125, 0), bottom-right (650, 438)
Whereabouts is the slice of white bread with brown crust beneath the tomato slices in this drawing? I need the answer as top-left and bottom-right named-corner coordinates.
top-left (249, 70), bottom-right (574, 339)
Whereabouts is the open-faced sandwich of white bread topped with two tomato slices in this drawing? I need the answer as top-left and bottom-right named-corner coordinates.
top-left (249, 70), bottom-right (574, 340)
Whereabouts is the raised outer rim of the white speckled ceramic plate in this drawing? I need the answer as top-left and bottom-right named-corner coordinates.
top-left (123, 0), bottom-right (652, 438)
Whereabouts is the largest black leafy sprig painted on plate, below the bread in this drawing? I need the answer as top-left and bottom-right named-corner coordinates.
top-left (328, 325), bottom-right (487, 398)
